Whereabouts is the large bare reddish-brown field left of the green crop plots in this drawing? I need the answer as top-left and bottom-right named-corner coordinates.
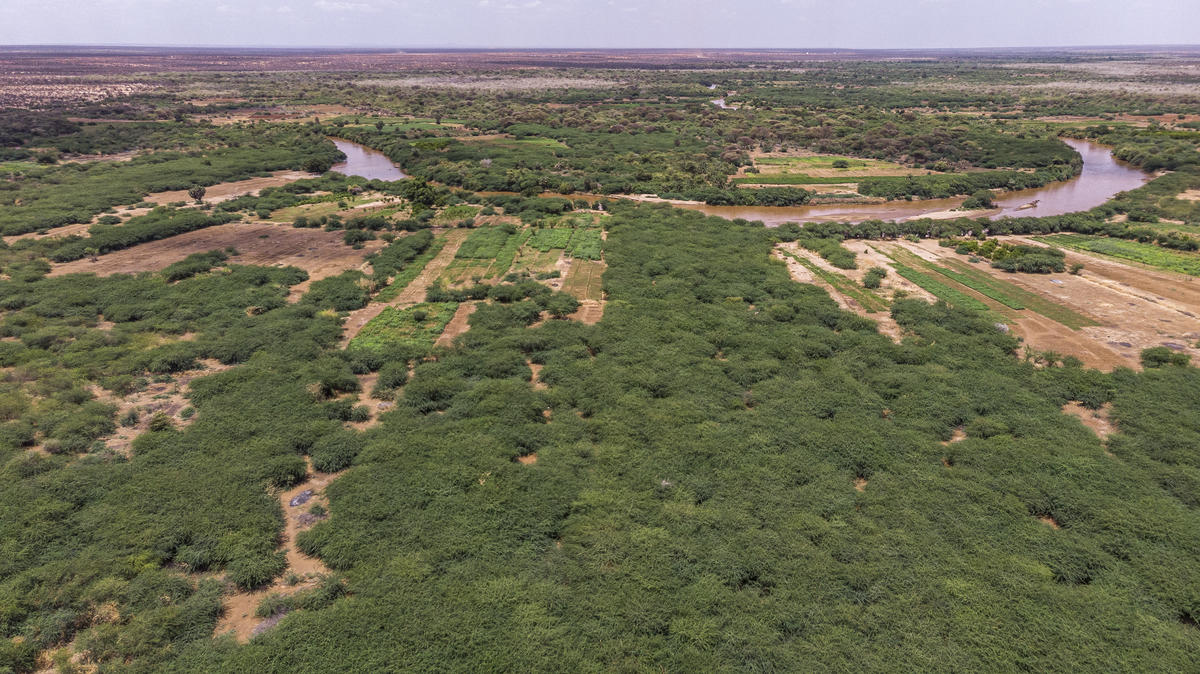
top-left (50, 222), bottom-right (385, 285)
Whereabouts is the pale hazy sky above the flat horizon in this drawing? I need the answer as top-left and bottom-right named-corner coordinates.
top-left (0, 0), bottom-right (1200, 49)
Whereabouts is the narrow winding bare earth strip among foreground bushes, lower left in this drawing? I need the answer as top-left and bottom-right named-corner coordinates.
top-left (214, 462), bottom-right (342, 642)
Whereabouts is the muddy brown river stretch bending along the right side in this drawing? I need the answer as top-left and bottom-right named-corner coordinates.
top-left (678, 138), bottom-right (1151, 227)
